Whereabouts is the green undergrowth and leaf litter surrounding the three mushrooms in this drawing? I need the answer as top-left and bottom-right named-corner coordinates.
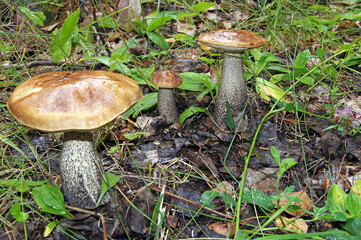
top-left (0, 0), bottom-right (361, 239)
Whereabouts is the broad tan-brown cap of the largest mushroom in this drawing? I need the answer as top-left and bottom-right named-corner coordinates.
top-left (7, 71), bottom-right (143, 132)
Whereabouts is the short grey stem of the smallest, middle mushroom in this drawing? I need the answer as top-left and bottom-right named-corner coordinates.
top-left (158, 88), bottom-right (179, 123)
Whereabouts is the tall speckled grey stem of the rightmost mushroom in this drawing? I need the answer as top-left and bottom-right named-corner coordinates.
top-left (215, 53), bottom-right (247, 128)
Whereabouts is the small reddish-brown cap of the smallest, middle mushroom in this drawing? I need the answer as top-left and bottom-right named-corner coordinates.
top-left (152, 70), bottom-right (183, 88)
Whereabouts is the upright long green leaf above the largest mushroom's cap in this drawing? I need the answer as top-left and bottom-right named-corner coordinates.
top-left (50, 8), bottom-right (79, 63)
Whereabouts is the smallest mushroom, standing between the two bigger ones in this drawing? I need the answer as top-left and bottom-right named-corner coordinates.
top-left (152, 70), bottom-right (183, 123)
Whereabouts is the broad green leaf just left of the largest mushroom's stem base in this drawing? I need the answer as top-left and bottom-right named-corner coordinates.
top-left (32, 184), bottom-right (72, 218)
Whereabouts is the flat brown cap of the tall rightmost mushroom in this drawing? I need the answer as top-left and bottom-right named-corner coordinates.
top-left (198, 29), bottom-right (267, 52)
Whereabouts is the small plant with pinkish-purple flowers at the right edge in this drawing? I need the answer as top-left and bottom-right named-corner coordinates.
top-left (323, 103), bottom-right (361, 135)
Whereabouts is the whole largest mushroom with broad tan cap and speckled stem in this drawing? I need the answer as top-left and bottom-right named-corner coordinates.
top-left (7, 71), bottom-right (143, 208)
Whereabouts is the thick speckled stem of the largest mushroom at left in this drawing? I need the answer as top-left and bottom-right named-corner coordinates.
top-left (60, 132), bottom-right (106, 208)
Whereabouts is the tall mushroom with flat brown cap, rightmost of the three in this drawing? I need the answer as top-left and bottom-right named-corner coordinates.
top-left (198, 30), bottom-right (267, 128)
